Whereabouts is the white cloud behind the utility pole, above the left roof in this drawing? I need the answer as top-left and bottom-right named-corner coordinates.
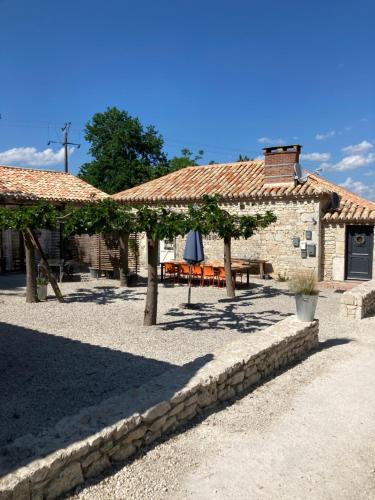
top-left (0, 147), bottom-right (74, 167)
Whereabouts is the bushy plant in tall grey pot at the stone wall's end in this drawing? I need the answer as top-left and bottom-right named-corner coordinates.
top-left (290, 271), bottom-right (319, 321)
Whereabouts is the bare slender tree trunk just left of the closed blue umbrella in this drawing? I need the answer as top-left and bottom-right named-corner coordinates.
top-left (143, 238), bottom-right (159, 326)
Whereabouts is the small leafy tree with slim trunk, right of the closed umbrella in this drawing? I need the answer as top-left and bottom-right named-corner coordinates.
top-left (188, 195), bottom-right (276, 297)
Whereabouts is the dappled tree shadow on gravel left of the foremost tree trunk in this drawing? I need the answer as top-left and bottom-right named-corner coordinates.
top-left (64, 286), bottom-right (144, 305)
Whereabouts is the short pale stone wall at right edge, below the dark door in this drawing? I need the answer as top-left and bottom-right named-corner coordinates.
top-left (341, 280), bottom-right (375, 319)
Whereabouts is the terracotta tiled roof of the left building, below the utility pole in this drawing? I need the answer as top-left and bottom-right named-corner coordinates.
top-left (0, 166), bottom-right (108, 202)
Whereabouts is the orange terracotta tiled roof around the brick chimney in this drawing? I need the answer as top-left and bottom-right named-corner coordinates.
top-left (113, 160), bottom-right (375, 221)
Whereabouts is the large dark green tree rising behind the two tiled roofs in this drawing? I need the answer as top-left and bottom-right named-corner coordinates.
top-left (78, 107), bottom-right (167, 194)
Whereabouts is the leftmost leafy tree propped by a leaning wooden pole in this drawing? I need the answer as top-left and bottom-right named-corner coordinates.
top-left (0, 202), bottom-right (63, 302)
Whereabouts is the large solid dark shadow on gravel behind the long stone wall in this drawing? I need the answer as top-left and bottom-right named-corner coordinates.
top-left (0, 322), bottom-right (212, 476)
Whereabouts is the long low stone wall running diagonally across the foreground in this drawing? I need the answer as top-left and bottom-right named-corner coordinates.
top-left (0, 316), bottom-right (319, 500)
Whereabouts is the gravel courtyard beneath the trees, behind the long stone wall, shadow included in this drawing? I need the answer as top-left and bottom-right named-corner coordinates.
top-left (0, 275), bottom-right (293, 447)
